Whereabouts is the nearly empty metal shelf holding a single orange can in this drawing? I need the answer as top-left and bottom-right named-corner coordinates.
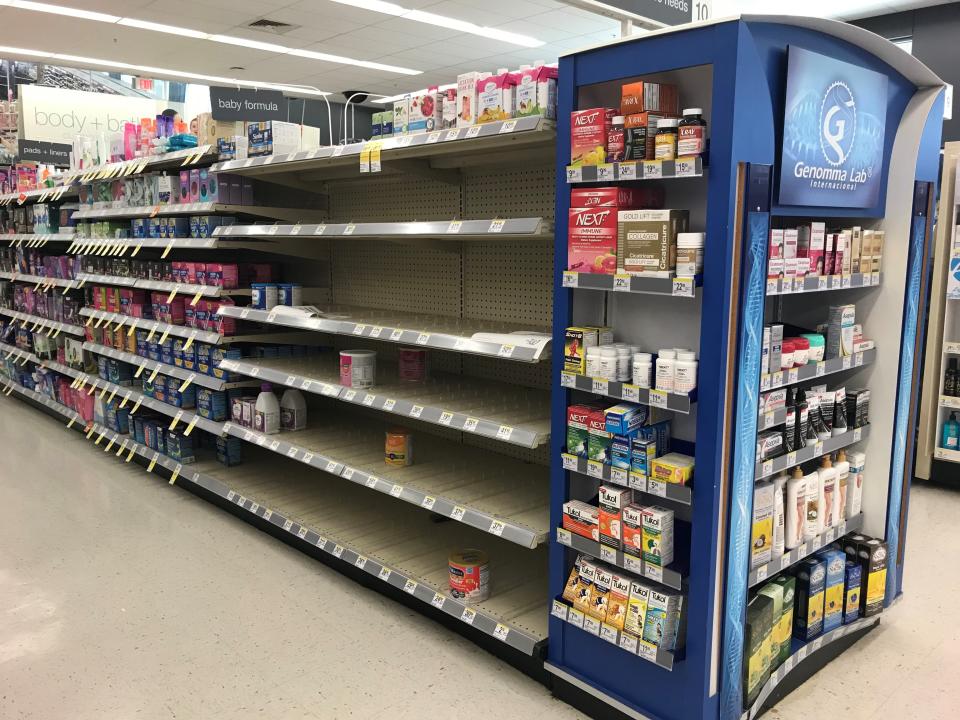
top-left (224, 416), bottom-right (549, 548)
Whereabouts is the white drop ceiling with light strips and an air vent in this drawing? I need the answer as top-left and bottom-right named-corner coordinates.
top-left (0, 0), bottom-right (948, 100)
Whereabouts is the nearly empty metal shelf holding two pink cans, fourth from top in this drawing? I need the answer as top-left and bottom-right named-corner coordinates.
top-left (220, 355), bottom-right (550, 448)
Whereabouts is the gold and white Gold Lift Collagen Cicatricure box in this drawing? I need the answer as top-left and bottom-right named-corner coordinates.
top-left (616, 210), bottom-right (689, 277)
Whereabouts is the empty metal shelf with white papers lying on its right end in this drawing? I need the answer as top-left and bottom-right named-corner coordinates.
top-left (220, 306), bottom-right (550, 362)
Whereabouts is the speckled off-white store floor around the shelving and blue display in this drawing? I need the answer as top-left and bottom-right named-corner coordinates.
top-left (0, 399), bottom-right (960, 720)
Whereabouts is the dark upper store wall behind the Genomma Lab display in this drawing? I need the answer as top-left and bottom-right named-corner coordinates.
top-left (851, 2), bottom-right (960, 142)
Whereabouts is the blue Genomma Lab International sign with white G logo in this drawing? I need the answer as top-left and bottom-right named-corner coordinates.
top-left (780, 46), bottom-right (887, 208)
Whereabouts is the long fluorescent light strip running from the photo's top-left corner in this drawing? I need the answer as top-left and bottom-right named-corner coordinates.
top-left (0, 0), bottom-right (420, 76)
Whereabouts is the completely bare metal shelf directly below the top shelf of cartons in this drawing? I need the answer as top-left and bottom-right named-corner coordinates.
top-left (213, 218), bottom-right (552, 240)
